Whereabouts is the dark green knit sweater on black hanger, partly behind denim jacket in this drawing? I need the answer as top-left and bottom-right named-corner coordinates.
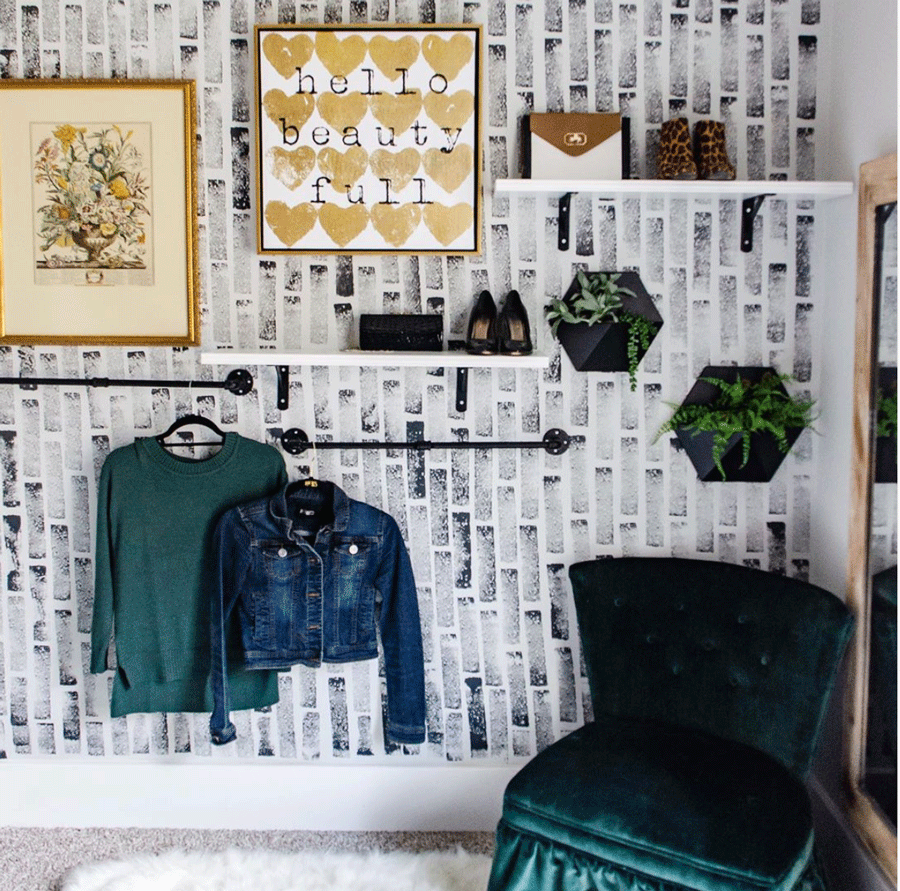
top-left (91, 433), bottom-right (287, 717)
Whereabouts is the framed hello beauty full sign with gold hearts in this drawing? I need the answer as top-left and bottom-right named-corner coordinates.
top-left (254, 24), bottom-right (484, 254)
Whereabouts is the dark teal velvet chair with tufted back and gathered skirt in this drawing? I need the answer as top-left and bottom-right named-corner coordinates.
top-left (488, 558), bottom-right (852, 891)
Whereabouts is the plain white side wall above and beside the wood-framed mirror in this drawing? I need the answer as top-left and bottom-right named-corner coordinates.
top-left (810, 0), bottom-right (897, 608)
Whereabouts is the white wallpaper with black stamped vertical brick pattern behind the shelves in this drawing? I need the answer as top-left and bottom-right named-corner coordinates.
top-left (0, 0), bottom-right (823, 763)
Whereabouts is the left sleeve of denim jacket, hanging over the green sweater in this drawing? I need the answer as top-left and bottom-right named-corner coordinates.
top-left (209, 509), bottom-right (250, 745)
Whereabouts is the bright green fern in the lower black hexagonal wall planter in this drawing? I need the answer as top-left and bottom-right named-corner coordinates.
top-left (654, 372), bottom-right (815, 479)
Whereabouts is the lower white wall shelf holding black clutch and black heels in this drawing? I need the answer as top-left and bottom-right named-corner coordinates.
top-left (200, 350), bottom-right (550, 368)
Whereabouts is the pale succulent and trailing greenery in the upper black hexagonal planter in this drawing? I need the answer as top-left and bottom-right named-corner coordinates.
top-left (546, 269), bottom-right (659, 392)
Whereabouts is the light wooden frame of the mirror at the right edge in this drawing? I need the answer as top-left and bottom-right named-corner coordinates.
top-left (844, 154), bottom-right (897, 882)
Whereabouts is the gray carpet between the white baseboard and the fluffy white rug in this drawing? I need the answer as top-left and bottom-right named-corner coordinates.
top-left (0, 828), bottom-right (494, 891)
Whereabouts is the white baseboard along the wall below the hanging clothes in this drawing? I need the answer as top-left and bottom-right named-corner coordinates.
top-left (0, 761), bottom-right (522, 831)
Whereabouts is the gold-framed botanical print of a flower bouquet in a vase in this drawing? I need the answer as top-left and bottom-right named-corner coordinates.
top-left (0, 80), bottom-right (200, 346)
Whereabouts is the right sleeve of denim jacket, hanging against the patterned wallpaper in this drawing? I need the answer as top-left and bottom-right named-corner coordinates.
top-left (376, 515), bottom-right (425, 745)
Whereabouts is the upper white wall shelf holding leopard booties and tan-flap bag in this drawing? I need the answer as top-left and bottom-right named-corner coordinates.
top-left (494, 179), bottom-right (853, 200)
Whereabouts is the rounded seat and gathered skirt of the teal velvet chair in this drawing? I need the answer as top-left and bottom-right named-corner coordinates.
top-left (490, 716), bottom-right (828, 891)
